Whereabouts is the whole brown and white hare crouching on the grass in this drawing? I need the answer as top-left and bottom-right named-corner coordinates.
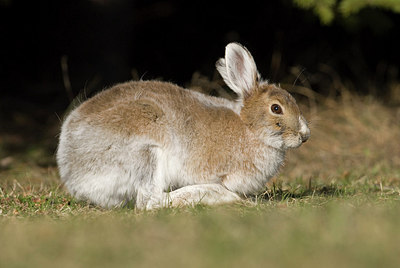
top-left (57, 43), bottom-right (310, 210)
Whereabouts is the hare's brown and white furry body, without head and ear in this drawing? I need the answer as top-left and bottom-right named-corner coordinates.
top-left (58, 81), bottom-right (284, 207)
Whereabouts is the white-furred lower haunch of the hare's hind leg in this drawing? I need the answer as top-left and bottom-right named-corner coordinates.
top-left (61, 145), bottom-right (163, 208)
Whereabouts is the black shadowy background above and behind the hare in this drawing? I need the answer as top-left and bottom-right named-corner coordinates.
top-left (0, 0), bottom-right (400, 151)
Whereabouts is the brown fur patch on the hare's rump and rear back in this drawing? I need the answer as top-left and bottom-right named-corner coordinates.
top-left (69, 81), bottom-right (219, 139)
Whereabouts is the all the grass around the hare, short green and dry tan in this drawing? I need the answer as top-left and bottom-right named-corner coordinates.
top-left (0, 89), bottom-right (400, 267)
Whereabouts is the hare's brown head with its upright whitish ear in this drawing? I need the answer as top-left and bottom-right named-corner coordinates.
top-left (216, 43), bottom-right (310, 150)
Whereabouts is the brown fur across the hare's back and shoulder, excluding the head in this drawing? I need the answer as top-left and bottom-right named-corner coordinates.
top-left (72, 81), bottom-right (259, 179)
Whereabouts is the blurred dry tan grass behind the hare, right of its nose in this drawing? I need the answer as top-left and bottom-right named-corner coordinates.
top-left (282, 90), bottom-right (400, 182)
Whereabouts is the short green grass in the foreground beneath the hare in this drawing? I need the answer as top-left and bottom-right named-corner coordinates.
top-left (0, 178), bottom-right (400, 267)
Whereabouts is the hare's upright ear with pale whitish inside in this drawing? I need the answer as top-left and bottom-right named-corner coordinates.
top-left (216, 43), bottom-right (260, 99)
